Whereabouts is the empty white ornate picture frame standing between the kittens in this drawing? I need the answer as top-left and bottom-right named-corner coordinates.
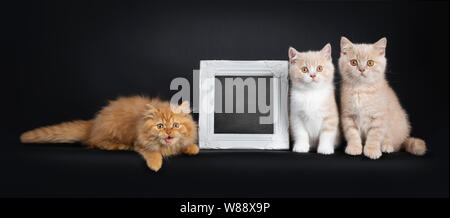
top-left (199, 60), bottom-right (289, 150)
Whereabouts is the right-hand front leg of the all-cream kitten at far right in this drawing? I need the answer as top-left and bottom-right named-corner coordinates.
top-left (364, 117), bottom-right (386, 159)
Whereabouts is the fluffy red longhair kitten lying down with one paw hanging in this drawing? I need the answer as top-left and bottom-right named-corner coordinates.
top-left (20, 96), bottom-right (199, 171)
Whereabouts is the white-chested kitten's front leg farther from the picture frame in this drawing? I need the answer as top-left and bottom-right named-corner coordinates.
top-left (317, 115), bottom-right (339, 154)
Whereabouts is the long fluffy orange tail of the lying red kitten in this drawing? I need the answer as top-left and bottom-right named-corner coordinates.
top-left (20, 120), bottom-right (92, 143)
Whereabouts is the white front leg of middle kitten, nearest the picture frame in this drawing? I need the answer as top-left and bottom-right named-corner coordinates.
top-left (291, 115), bottom-right (310, 153)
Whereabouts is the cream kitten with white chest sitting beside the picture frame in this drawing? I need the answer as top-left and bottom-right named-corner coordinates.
top-left (289, 44), bottom-right (339, 154)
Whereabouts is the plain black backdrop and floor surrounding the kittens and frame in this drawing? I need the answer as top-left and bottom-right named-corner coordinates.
top-left (0, 0), bottom-right (449, 197)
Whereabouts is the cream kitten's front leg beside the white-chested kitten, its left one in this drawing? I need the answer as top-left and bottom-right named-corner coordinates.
top-left (341, 114), bottom-right (362, 155)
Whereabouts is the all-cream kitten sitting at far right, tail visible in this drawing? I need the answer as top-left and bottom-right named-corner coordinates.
top-left (339, 37), bottom-right (426, 159)
